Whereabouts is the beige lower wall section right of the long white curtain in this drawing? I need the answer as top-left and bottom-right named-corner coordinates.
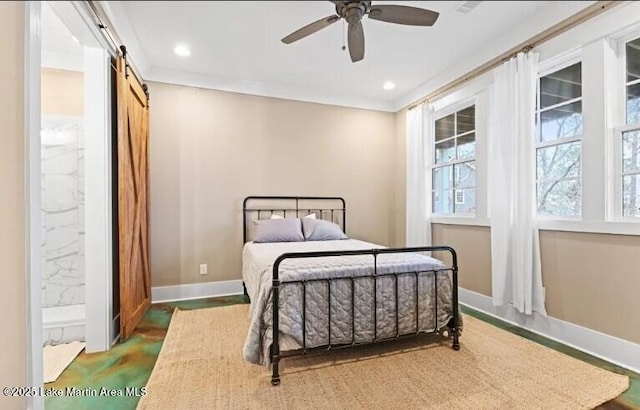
top-left (540, 231), bottom-right (640, 343)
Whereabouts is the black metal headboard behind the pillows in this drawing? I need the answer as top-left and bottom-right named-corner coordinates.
top-left (242, 196), bottom-right (347, 243)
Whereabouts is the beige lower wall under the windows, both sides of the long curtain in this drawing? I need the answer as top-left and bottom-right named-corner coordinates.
top-left (433, 224), bottom-right (640, 343)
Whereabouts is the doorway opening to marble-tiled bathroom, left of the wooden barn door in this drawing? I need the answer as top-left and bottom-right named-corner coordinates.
top-left (36, 1), bottom-right (118, 368)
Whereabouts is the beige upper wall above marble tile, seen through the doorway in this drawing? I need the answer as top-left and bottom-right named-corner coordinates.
top-left (41, 68), bottom-right (84, 117)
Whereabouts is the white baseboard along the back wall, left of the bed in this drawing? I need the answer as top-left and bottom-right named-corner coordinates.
top-left (151, 279), bottom-right (244, 303)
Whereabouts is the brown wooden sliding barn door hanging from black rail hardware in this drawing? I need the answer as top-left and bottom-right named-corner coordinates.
top-left (117, 58), bottom-right (151, 340)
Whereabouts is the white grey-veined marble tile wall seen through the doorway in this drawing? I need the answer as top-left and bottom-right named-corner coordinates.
top-left (41, 115), bottom-right (85, 308)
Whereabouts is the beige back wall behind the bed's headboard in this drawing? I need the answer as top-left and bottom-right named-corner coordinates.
top-left (150, 83), bottom-right (398, 286)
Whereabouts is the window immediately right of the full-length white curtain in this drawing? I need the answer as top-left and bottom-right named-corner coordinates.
top-left (536, 63), bottom-right (583, 217)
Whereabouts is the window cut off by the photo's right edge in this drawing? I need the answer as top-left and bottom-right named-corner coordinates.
top-left (621, 38), bottom-right (640, 217)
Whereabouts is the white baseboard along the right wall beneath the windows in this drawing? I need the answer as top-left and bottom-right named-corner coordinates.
top-left (459, 288), bottom-right (640, 373)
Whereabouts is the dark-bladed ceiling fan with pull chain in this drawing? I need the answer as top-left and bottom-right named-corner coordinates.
top-left (282, 1), bottom-right (440, 63)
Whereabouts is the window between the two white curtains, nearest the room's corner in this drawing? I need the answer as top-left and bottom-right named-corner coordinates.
top-left (432, 105), bottom-right (476, 214)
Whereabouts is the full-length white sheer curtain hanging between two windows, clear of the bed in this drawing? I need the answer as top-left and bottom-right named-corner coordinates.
top-left (488, 53), bottom-right (546, 315)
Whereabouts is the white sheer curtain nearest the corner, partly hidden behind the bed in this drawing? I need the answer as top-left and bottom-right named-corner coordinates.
top-left (406, 104), bottom-right (433, 246)
